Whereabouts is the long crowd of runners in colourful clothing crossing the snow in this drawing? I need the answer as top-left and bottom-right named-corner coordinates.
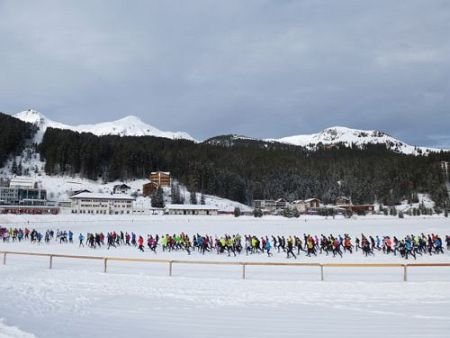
top-left (0, 227), bottom-right (450, 259)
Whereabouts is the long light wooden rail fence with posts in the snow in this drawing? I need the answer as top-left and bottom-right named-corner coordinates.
top-left (0, 251), bottom-right (450, 282)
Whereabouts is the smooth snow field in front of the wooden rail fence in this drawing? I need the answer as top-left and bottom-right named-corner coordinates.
top-left (0, 265), bottom-right (450, 337)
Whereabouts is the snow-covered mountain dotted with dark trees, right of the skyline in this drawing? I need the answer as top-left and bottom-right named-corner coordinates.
top-left (265, 127), bottom-right (441, 154)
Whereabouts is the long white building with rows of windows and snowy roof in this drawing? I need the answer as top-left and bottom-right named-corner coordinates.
top-left (70, 193), bottom-right (134, 215)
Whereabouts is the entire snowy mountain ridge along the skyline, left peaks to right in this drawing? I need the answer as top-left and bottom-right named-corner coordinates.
top-left (14, 109), bottom-right (448, 155)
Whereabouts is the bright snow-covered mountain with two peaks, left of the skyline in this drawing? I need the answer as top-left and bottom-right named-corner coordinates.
top-left (14, 109), bottom-right (196, 143)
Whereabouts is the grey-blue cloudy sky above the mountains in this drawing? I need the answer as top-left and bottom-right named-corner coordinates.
top-left (0, 0), bottom-right (450, 148)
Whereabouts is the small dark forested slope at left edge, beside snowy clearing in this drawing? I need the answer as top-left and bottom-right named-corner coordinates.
top-left (0, 113), bottom-right (36, 168)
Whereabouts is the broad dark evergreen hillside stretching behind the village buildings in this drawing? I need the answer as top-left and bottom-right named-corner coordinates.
top-left (40, 128), bottom-right (450, 205)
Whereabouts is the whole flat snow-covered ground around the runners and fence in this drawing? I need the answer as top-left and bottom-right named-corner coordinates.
top-left (0, 215), bottom-right (450, 338)
